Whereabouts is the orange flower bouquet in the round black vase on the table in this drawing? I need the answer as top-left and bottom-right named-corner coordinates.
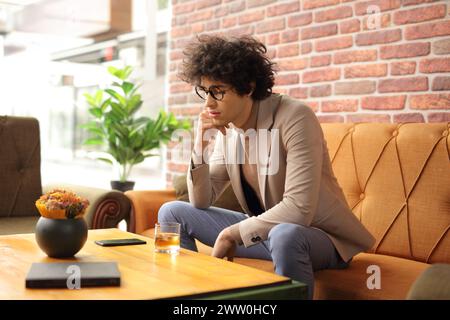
top-left (36, 189), bottom-right (89, 219)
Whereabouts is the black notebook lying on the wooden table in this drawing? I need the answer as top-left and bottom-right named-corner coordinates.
top-left (25, 262), bottom-right (120, 289)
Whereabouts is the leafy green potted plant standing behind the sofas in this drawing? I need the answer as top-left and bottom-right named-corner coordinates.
top-left (82, 66), bottom-right (191, 191)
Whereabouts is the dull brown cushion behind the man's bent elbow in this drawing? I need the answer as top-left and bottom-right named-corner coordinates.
top-left (172, 175), bottom-right (244, 212)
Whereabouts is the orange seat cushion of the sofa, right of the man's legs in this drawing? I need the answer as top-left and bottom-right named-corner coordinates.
top-left (314, 253), bottom-right (430, 300)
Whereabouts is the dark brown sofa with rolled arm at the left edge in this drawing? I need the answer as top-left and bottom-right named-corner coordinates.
top-left (0, 116), bottom-right (130, 235)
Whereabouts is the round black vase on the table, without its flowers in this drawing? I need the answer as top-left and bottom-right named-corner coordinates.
top-left (35, 217), bottom-right (88, 258)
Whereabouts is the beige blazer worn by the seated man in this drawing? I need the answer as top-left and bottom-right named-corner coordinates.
top-left (187, 94), bottom-right (375, 261)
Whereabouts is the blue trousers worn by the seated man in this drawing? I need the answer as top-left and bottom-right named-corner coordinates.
top-left (158, 201), bottom-right (348, 299)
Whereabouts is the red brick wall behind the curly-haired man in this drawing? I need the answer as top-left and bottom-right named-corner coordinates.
top-left (167, 0), bottom-right (450, 185)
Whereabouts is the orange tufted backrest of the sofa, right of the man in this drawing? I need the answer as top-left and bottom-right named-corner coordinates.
top-left (322, 123), bottom-right (450, 263)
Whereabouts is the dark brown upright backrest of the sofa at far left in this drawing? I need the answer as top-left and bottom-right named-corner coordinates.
top-left (0, 116), bottom-right (42, 217)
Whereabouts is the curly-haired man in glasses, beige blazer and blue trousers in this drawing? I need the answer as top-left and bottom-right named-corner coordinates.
top-left (158, 36), bottom-right (375, 298)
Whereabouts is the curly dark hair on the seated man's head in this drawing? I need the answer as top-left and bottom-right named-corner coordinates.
top-left (179, 35), bottom-right (275, 100)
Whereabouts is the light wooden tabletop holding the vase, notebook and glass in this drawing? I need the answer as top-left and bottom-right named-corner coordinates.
top-left (0, 229), bottom-right (306, 300)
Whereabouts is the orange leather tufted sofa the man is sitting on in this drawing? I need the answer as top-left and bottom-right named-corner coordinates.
top-left (126, 123), bottom-right (450, 299)
